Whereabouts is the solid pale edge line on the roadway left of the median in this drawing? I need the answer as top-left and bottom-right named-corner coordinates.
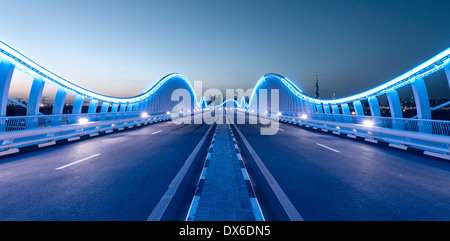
top-left (147, 125), bottom-right (214, 221)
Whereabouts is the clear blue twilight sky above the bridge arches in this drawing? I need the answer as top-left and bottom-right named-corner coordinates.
top-left (0, 0), bottom-right (450, 99)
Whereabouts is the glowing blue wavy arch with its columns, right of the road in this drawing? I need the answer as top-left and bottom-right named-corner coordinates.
top-left (245, 48), bottom-right (450, 119)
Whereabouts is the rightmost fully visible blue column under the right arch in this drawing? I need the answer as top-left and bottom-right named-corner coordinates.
top-left (411, 77), bottom-right (431, 119)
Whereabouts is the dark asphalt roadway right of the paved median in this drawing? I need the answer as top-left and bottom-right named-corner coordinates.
top-left (237, 112), bottom-right (450, 220)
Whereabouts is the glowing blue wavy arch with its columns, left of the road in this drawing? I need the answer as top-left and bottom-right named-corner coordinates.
top-left (0, 42), bottom-right (203, 116)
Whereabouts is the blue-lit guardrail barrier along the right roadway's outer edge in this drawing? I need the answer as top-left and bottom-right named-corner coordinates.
top-left (237, 109), bottom-right (450, 155)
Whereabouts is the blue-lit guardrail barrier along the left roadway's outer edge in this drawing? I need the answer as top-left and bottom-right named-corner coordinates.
top-left (0, 112), bottom-right (175, 151)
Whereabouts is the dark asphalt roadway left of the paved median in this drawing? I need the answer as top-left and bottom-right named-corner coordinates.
top-left (0, 118), bottom-right (209, 220)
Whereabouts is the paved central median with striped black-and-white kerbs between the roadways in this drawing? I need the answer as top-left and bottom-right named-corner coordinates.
top-left (187, 121), bottom-right (262, 221)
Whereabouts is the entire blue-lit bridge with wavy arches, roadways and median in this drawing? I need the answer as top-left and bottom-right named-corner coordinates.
top-left (0, 42), bottom-right (450, 222)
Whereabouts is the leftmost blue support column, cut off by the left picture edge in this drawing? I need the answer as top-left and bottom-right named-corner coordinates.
top-left (0, 59), bottom-right (14, 116)
